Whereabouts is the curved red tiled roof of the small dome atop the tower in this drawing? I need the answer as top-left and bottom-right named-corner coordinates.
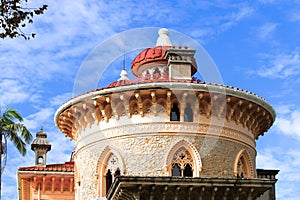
top-left (131, 46), bottom-right (170, 76)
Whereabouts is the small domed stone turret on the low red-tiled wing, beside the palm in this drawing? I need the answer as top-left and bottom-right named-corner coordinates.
top-left (31, 127), bottom-right (51, 165)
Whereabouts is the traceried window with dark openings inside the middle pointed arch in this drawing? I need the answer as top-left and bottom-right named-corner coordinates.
top-left (172, 147), bottom-right (194, 177)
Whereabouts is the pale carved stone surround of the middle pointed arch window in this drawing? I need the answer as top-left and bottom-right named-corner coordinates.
top-left (165, 139), bottom-right (202, 177)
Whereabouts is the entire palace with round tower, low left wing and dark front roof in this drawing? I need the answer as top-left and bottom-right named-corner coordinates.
top-left (18, 28), bottom-right (278, 200)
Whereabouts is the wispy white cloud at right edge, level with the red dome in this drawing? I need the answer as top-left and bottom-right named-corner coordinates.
top-left (258, 51), bottom-right (300, 79)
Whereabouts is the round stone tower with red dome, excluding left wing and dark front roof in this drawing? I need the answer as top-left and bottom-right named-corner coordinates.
top-left (55, 29), bottom-right (275, 199)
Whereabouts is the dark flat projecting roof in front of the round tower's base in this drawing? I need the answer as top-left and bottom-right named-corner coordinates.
top-left (106, 176), bottom-right (276, 200)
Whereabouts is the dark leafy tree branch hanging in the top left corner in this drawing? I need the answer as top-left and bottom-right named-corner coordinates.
top-left (0, 0), bottom-right (47, 40)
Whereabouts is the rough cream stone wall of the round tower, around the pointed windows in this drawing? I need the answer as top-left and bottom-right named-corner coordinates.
top-left (75, 119), bottom-right (256, 199)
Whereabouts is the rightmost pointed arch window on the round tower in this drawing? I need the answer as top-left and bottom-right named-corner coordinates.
top-left (233, 149), bottom-right (255, 178)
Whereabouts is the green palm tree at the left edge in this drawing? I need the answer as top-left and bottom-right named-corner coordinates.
top-left (0, 109), bottom-right (32, 200)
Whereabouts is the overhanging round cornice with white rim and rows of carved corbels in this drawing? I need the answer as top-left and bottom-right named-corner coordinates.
top-left (55, 82), bottom-right (275, 139)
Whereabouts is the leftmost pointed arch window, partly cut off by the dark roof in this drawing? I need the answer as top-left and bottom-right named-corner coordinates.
top-left (96, 146), bottom-right (126, 197)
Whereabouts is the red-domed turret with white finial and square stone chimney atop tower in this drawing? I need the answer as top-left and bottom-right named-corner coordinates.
top-left (131, 28), bottom-right (197, 80)
